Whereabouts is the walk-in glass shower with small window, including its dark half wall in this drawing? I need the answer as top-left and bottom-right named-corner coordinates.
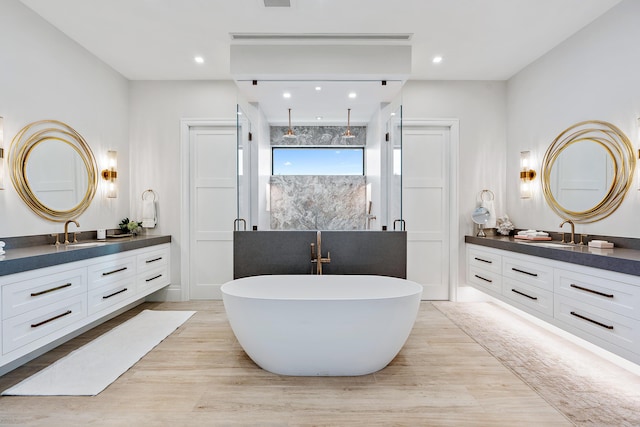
top-left (234, 80), bottom-right (406, 278)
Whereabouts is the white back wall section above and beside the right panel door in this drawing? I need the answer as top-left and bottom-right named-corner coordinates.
top-left (402, 81), bottom-right (507, 283)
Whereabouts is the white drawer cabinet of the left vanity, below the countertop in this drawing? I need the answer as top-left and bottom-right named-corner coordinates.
top-left (0, 243), bottom-right (170, 375)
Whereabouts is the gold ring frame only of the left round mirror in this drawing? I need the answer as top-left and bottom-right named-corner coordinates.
top-left (9, 120), bottom-right (98, 222)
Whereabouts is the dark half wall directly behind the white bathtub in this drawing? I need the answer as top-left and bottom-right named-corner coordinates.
top-left (233, 231), bottom-right (407, 279)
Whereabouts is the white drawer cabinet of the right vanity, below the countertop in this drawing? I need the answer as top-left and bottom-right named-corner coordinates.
top-left (466, 243), bottom-right (640, 363)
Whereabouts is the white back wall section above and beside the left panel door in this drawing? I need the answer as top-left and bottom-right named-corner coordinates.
top-left (129, 81), bottom-right (237, 300)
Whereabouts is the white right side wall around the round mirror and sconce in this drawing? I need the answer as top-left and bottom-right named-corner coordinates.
top-left (506, 0), bottom-right (640, 238)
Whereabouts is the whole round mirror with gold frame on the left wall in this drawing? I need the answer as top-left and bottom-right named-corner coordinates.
top-left (9, 120), bottom-right (98, 222)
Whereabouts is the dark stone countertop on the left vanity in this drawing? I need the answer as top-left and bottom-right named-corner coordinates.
top-left (0, 236), bottom-right (171, 276)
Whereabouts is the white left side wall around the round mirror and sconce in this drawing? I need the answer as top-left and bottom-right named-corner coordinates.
top-left (0, 0), bottom-right (129, 237)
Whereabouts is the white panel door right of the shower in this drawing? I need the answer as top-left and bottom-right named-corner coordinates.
top-left (402, 125), bottom-right (451, 300)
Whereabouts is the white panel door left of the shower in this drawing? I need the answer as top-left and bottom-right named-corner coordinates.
top-left (189, 126), bottom-right (237, 299)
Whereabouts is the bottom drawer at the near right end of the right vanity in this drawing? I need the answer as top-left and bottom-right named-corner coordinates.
top-left (554, 295), bottom-right (640, 353)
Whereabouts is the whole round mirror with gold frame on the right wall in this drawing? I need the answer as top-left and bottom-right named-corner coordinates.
top-left (542, 121), bottom-right (635, 223)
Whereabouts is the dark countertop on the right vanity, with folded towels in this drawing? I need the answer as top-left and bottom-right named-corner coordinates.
top-left (464, 236), bottom-right (640, 276)
